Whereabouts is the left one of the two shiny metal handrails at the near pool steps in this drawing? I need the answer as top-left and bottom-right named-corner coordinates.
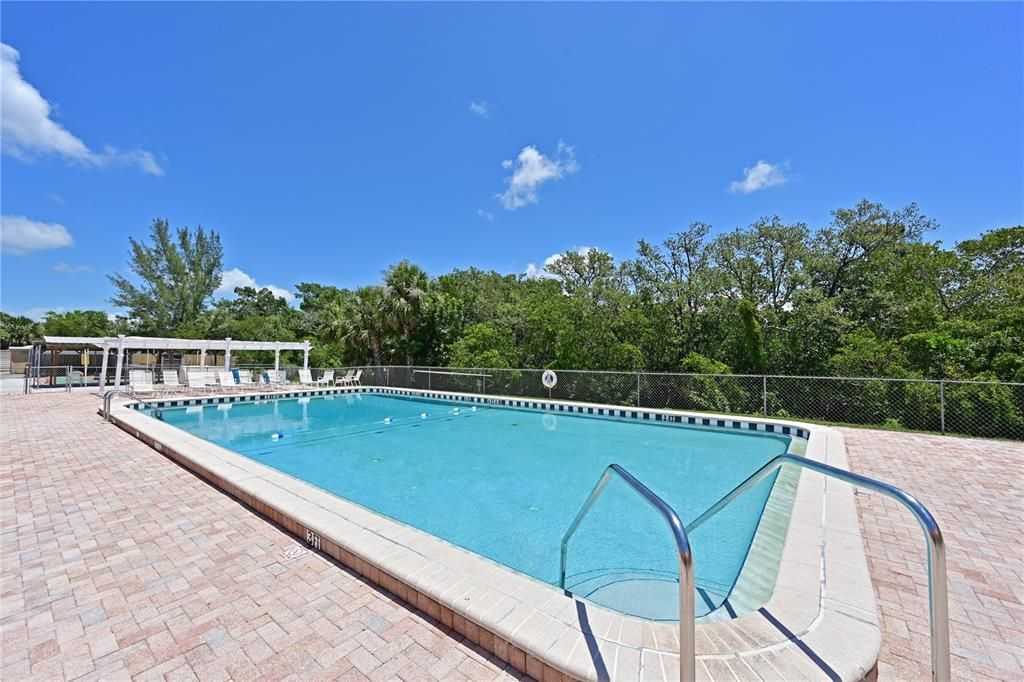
top-left (558, 464), bottom-right (696, 682)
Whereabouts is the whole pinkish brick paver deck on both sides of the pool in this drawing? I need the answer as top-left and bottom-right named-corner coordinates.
top-left (0, 393), bottom-right (1024, 681)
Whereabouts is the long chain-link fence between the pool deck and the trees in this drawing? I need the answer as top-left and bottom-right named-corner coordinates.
top-left (354, 367), bottom-right (1024, 440)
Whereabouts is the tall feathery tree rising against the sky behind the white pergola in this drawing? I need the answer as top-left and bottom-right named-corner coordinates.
top-left (109, 218), bottom-right (223, 336)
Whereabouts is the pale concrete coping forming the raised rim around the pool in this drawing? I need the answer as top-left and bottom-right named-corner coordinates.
top-left (103, 389), bottom-right (881, 680)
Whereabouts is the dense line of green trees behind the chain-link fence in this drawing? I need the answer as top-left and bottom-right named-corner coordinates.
top-left (0, 201), bottom-right (1024, 381)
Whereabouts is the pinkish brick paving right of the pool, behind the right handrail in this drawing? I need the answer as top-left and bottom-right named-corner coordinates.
top-left (842, 429), bottom-right (1024, 680)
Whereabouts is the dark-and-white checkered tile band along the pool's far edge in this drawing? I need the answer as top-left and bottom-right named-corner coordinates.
top-left (132, 386), bottom-right (810, 440)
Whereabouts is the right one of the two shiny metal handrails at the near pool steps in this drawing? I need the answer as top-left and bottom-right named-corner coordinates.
top-left (684, 455), bottom-right (950, 682)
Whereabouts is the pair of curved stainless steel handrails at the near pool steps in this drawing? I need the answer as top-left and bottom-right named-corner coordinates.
top-left (559, 455), bottom-right (950, 682)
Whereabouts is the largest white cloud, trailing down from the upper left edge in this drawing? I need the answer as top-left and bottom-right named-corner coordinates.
top-left (0, 43), bottom-right (164, 175)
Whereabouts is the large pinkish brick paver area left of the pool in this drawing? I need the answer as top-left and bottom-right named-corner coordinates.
top-left (0, 393), bottom-right (517, 682)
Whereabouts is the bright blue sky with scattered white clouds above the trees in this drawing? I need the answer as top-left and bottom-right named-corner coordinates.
top-left (0, 3), bottom-right (1024, 315)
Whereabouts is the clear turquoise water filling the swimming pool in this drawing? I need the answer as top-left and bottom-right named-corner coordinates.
top-left (153, 393), bottom-right (788, 620)
